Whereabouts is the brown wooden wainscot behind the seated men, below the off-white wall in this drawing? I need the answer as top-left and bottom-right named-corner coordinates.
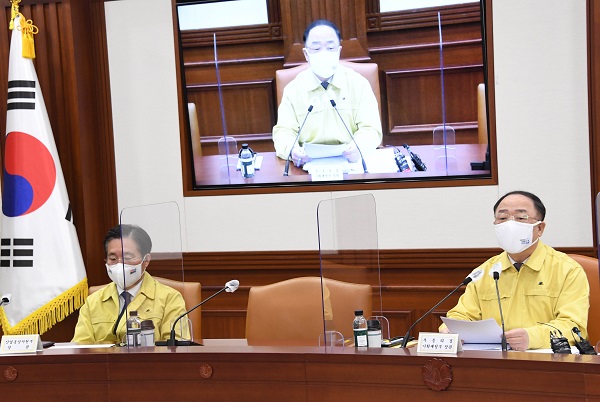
top-left (23, 248), bottom-right (595, 342)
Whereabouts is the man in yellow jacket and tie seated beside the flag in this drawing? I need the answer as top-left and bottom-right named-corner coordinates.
top-left (72, 225), bottom-right (189, 344)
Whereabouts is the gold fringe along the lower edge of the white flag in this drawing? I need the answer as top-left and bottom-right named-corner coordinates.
top-left (0, 278), bottom-right (88, 335)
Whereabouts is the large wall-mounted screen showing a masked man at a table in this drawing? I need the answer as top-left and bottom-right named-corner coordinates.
top-left (178, 0), bottom-right (495, 195)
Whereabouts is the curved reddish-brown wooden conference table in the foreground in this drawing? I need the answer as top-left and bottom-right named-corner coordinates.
top-left (0, 340), bottom-right (600, 402)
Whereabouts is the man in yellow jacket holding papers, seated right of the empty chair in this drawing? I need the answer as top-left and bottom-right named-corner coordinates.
top-left (440, 191), bottom-right (590, 351)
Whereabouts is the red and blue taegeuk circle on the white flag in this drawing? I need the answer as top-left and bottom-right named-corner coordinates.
top-left (2, 131), bottom-right (56, 217)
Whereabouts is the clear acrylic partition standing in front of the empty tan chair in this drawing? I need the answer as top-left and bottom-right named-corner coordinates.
top-left (317, 194), bottom-right (382, 347)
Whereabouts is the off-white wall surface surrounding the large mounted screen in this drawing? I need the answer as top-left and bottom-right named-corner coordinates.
top-left (105, 0), bottom-right (593, 252)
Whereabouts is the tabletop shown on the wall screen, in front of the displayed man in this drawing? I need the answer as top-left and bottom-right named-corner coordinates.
top-left (194, 144), bottom-right (490, 187)
